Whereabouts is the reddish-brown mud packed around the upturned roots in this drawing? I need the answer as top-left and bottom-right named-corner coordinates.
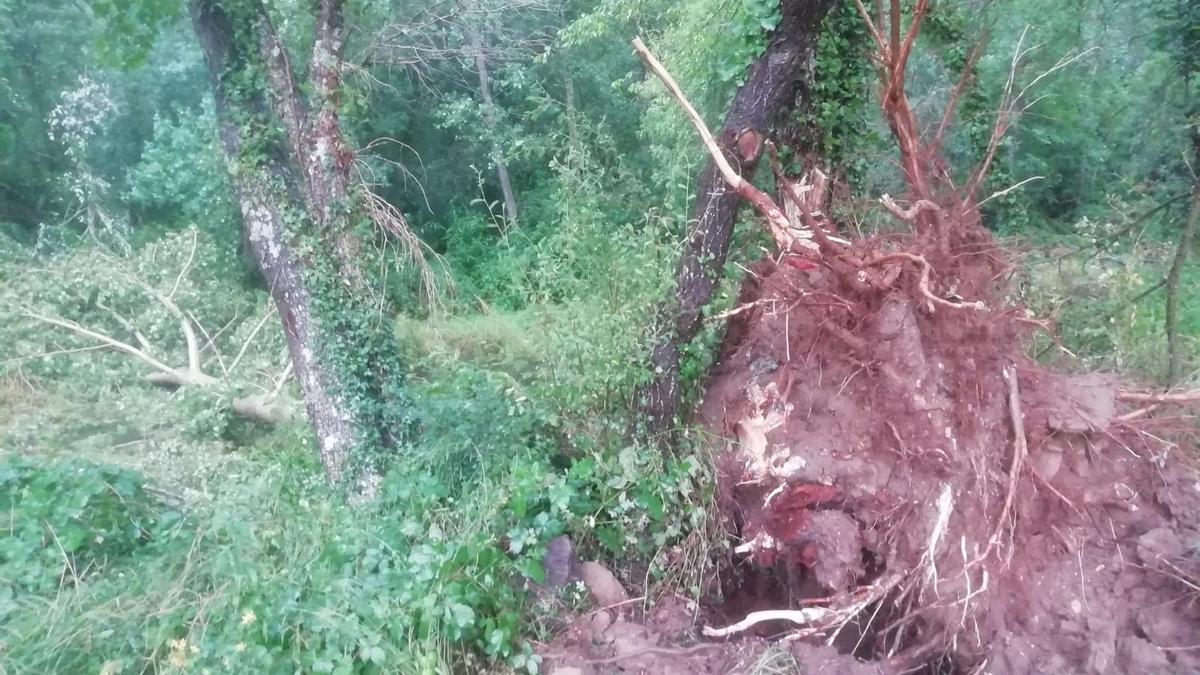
top-left (701, 253), bottom-right (1200, 674)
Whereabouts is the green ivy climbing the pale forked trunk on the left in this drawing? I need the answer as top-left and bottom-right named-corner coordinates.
top-left (206, 1), bottom-right (415, 479)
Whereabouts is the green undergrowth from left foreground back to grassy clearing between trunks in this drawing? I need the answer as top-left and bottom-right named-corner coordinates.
top-left (0, 297), bottom-right (720, 675)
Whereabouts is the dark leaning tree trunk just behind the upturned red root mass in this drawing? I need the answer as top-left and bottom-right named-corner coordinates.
top-left (634, 0), bottom-right (834, 435)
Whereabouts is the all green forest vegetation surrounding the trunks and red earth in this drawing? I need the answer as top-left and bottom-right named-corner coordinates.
top-left (0, 0), bottom-right (1200, 675)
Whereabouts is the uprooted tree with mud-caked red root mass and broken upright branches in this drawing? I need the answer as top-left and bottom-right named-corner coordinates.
top-left (635, 0), bottom-right (1200, 673)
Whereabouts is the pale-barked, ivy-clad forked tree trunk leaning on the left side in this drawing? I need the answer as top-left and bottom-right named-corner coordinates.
top-left (188, 0), bottom-right (407, 489)
